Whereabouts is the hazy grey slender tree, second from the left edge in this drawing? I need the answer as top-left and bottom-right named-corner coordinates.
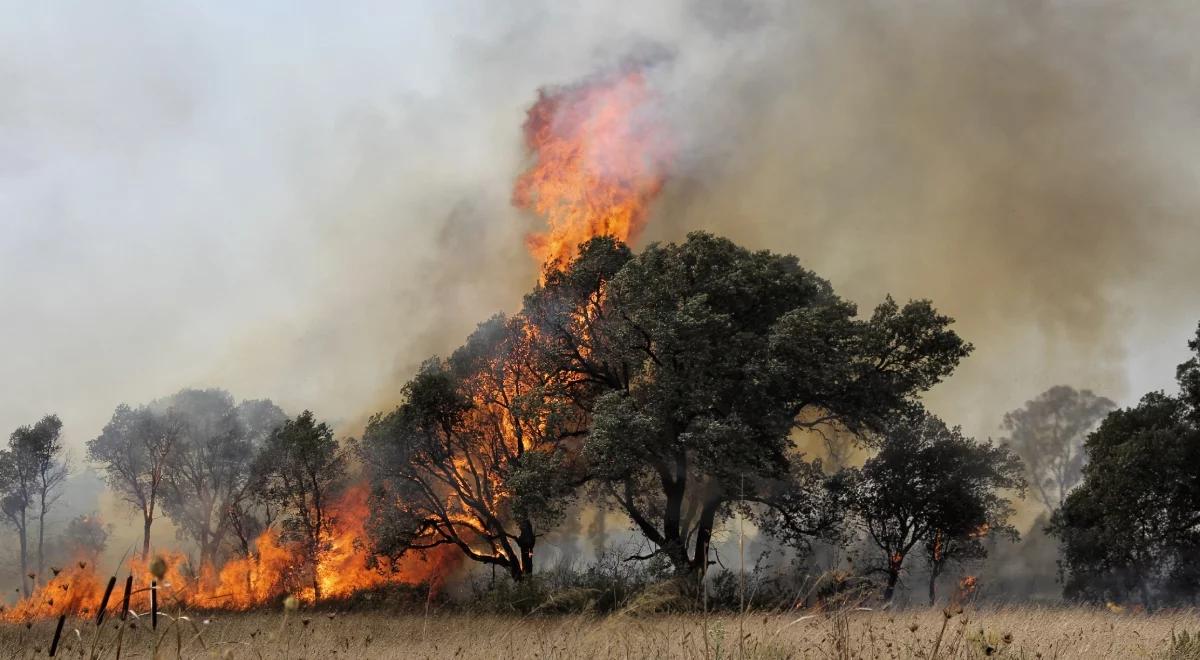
top-left (88, 403), bottom-right (184, 559)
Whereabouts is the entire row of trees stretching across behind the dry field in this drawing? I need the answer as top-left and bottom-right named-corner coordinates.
top-left (7, 233), bottom-right (1200, 605)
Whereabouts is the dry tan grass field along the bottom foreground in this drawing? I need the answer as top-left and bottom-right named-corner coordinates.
top-left (0, 606), bottom-right (1200, 659)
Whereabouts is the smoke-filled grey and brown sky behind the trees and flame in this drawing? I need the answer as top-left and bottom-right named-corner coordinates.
top-left (0, 0), bottom-right (1200, 465)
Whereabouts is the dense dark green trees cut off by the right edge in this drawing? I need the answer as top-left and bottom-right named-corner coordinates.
top-left (1050, 331), bottom-right (1200, 607)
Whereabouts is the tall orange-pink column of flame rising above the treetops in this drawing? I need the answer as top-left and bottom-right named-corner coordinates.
top-left (512, 70), bottom-right (672, 271)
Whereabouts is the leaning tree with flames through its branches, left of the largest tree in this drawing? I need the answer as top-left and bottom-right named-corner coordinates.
top-left (361, 316), bottom-right (583, 580)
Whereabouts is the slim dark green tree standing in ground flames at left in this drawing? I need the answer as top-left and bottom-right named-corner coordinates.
top-left (256, 410), bottom-right (347, 600)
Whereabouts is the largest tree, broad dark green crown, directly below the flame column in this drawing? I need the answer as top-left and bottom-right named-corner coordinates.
top-left (527, 233), bottom-right (970, 575)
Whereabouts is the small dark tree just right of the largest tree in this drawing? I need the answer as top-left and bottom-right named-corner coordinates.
top-left (838, 406), bottom-right (1025, 601)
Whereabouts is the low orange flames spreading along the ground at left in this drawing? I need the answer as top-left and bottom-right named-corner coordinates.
top-left (0, 485), bottom-right (461, 622)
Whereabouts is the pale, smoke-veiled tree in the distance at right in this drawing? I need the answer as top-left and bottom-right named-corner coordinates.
top-left (1003, 385), bottom-right (1116, 512)
